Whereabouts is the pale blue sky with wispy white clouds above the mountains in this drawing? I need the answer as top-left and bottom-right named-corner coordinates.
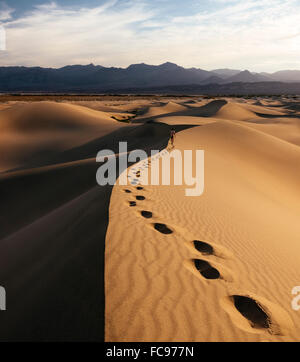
top-left (0, 0), bottom-right (300, 72)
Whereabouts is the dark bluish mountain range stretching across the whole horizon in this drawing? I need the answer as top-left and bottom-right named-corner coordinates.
top-left (0, 62), bottom-right (300, 93)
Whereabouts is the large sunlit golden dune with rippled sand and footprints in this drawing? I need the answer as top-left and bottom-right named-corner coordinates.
top-left (105, 99), bottom-right (300, 341)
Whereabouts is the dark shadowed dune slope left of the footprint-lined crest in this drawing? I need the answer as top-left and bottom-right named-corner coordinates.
top-left (0, 100), bottom-right (192, 341)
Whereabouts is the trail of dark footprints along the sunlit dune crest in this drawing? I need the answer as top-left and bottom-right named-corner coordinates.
top-left (124, 151), bottom-right (280, 334)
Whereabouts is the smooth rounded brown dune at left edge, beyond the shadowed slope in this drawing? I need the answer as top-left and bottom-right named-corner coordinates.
top-left (0, 102), bottom-right (124, 171)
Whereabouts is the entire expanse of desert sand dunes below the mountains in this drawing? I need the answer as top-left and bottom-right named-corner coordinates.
top-left (0, 96), bottom-right (300, 341)
